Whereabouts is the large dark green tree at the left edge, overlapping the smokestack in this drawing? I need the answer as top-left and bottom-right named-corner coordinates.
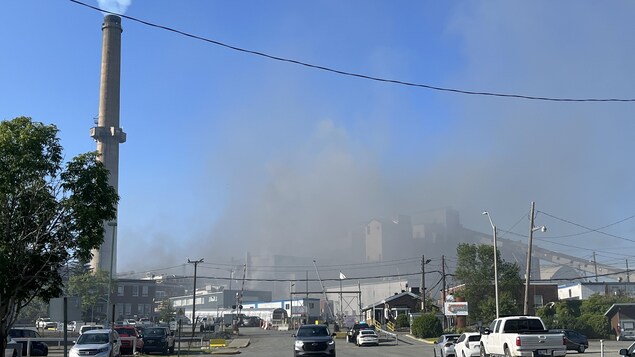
top-left (0, 117), bottom-right (119, 356)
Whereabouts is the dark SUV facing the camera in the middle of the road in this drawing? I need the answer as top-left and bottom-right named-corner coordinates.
top-left (292, 325), bottom-right (335, 357)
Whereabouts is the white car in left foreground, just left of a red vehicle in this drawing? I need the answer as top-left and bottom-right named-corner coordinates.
top-left (69, 329), bottom-right (121, 357)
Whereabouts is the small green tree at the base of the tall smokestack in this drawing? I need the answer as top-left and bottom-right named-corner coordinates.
top-left (68, 270), bottom-right (110, 321)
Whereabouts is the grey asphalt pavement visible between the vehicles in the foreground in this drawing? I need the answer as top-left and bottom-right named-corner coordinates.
top-left (49, 327), bottom-right (632, 357)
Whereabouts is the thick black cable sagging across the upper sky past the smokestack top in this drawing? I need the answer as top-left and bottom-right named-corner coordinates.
top-left (69, 0), bottom-right (635, 102)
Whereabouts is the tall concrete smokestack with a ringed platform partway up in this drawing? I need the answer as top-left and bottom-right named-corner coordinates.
top-left (90, 15), bottom-right (126, 274)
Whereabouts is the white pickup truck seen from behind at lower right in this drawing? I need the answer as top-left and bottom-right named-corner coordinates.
top-left (481, 316), bottom-right (567, 357)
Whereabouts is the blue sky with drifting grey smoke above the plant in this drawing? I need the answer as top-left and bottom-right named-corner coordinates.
top-left (0, 0), bottom-right (635, 278)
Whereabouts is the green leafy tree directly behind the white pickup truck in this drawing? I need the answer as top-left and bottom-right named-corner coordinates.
top-left (454, 243), bottom-right (523, 324)
